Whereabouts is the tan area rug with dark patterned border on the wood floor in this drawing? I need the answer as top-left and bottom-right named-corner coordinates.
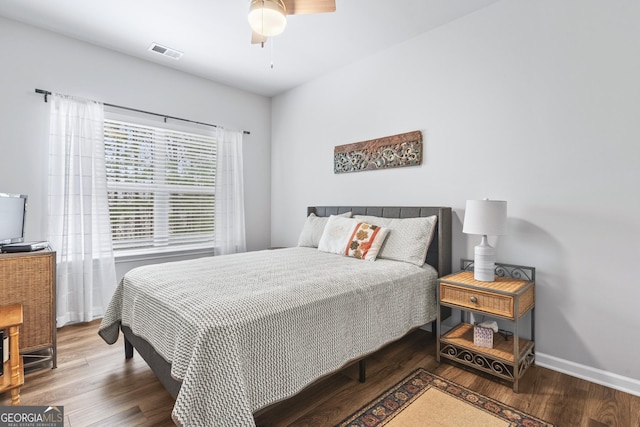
top-left (339, 368), bottom-right (553, 427)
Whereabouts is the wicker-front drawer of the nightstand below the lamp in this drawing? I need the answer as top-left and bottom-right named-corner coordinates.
top-left (440, 283), bottom-right (514, 319)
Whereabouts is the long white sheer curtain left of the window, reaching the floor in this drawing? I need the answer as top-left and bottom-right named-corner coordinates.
top-left (48, 94), bottom-right (116, 327)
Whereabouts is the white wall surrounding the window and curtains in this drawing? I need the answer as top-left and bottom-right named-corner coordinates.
top-left (0, 18), bottom-right (271, 275)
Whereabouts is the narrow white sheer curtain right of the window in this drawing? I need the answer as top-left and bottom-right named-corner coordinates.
top-left (215, 127), bottom-right (247, 255)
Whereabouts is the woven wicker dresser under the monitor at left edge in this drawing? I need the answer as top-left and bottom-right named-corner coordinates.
top-left (0, 250), bottom-right (57, 369)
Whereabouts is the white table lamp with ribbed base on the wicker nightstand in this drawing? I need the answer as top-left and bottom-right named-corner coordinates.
top-left (462, 199), bottom-right (507, 282)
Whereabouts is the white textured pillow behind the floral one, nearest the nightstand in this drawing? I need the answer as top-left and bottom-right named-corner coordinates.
top-left (354, 215), bottom-right (438, 266)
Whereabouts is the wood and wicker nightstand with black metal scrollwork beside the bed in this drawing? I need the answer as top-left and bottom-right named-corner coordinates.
top-left (436, 260), bottom-right (535, 393)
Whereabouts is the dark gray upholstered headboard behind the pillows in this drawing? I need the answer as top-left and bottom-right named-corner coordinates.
top-left (307, 206), bottom-right (451, 277)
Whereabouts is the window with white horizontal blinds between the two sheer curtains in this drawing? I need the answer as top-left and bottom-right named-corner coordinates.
top-left (104, 119), bottom-right (216, 255)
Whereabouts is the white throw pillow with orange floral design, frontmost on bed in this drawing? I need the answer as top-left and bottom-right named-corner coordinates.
top-left (318, 215), bottom-right (389, 261)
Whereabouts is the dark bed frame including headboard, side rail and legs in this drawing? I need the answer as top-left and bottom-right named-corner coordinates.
top-left (120, 206), bottom-right (451, 398)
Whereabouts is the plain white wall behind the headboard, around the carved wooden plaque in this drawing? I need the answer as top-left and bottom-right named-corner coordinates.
top-left (272, 0), bottom-right (640, 394)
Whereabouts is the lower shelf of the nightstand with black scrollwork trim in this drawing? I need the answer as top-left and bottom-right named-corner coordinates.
top-left (440, 323), bottom-right (535, 381)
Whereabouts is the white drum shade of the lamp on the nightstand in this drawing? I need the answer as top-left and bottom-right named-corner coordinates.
top-left (462, 199), bottom-right (507, 236)
